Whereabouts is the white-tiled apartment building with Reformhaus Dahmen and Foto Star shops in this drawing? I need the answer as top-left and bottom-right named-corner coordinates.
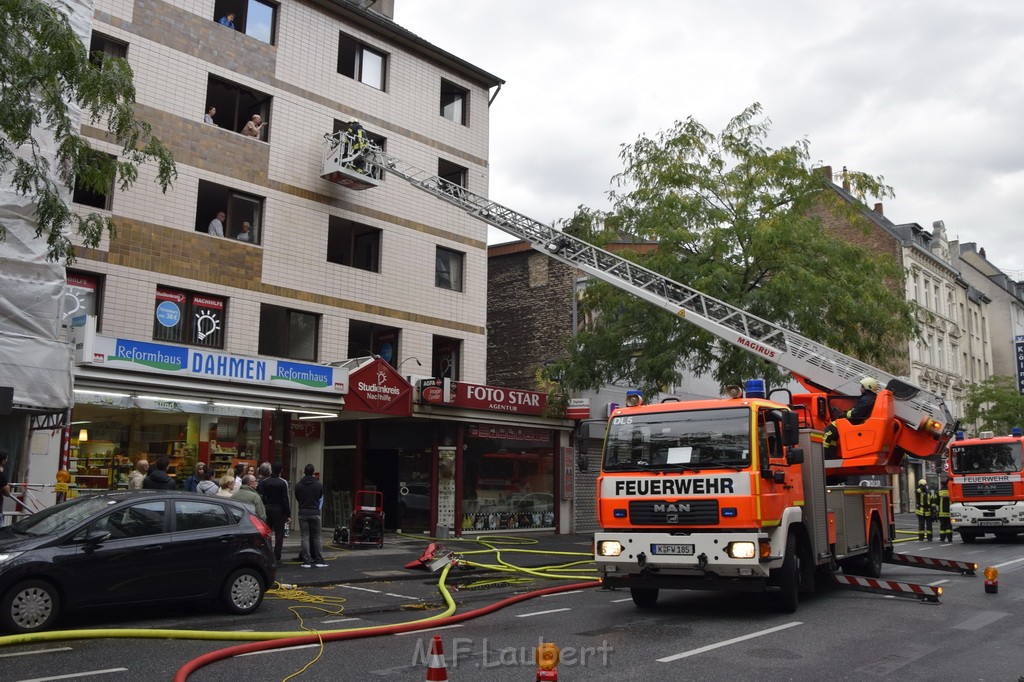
top-left (54, 0), bottom-right (570, 530)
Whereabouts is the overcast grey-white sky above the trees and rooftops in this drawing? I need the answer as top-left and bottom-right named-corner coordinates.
top-left (394, 0), bottom-right (1024, 279)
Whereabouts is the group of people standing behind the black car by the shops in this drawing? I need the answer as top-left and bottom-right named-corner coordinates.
top-left (128, 456), bottom-right (327, 568)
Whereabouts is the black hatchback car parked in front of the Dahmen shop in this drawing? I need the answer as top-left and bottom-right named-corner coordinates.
top-left (0, 491), bottom-right (276, 633)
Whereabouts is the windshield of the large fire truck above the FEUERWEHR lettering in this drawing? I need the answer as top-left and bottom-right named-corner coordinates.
top-left (604, 408), bottom-right (751, 471)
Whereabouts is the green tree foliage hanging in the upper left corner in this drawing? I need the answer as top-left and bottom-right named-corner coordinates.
top-left (0, 0), bottom-right (177, 264)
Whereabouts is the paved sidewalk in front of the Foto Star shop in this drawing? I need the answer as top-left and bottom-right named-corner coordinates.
top-left (278, 529), bottom-right (594, 586)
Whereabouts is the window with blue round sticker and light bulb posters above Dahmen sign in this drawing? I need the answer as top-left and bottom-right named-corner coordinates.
top-left (153, 287), bottom-right (227, 348)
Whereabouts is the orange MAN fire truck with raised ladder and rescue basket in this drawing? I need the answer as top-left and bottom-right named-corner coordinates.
top-left (322, 132), bottom-right (956, 612)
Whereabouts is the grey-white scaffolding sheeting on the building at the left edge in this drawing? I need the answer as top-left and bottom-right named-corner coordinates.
top-left (0, 0), bottom-right (92, 412)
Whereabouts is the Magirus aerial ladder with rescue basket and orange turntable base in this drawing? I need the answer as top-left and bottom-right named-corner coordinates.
top-left (322, 131), bottom-right (956, 474)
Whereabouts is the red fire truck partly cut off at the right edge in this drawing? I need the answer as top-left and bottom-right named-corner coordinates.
top-left (949, 427), bottom-right (1024, 543)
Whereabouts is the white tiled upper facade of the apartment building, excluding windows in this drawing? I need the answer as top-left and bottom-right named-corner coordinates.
top-left (76, 0), bottom-right (497, 383)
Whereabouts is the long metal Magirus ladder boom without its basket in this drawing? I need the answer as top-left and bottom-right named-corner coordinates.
top-left (319, 133), bottom-right (954, 448)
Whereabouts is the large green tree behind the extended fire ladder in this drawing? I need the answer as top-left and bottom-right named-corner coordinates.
top-left (558, 103), bottom-right (915, 391)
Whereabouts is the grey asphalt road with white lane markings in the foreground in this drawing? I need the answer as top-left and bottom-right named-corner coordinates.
top-left (0, 540), bottom-right (1024, 682)
